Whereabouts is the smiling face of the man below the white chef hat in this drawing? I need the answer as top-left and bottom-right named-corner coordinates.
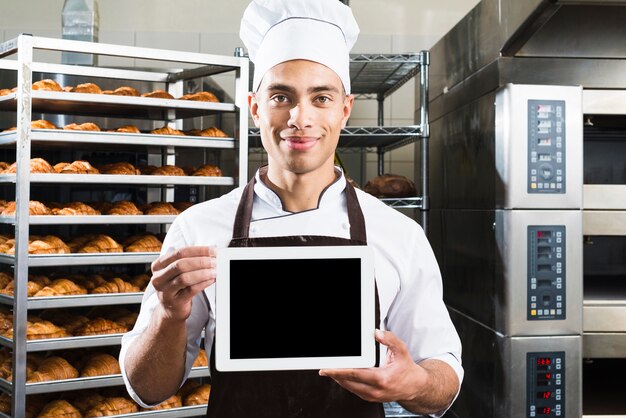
top-left (248, 60), bottom-right (354, 174)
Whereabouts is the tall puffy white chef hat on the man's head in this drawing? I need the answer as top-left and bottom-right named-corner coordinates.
top-left (239, 0), bottom-right (359, 94)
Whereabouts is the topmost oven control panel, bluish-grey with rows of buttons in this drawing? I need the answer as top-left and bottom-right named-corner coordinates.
top-left (528, 100), bottom-right (565, 194)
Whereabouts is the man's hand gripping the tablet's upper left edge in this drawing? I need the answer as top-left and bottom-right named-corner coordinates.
top-left (152, 246), bottom-right (217, 321)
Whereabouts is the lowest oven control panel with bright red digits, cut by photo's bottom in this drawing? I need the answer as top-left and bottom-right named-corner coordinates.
top-left (526, 351), bottom-right (565, 418)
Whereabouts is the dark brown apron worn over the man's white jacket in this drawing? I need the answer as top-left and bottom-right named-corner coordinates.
top-left (207, 179), bottom-right (385, 418)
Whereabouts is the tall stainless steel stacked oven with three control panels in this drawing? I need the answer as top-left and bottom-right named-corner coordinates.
top-left (416, 0), bottom-right (626, 418)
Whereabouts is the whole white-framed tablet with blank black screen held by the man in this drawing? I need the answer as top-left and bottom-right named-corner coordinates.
top-left (215, 245), bottom-right (376, 371)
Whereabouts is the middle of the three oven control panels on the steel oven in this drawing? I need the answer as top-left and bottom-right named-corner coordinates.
top-left (527, 225), bottom-right (566, 321)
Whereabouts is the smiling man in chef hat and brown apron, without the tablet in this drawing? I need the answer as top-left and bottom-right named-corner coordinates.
top-left (120, 0), bottom-right (463, 418)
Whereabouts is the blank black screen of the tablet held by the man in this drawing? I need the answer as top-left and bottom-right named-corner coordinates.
top-left (230, 258), bottom-right (361, 359)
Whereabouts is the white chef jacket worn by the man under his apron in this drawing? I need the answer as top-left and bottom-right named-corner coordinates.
top-left (119, 168), bottom-right (463, 416)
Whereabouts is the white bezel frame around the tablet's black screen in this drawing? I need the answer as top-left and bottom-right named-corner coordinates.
top-left (214, 245), bottom-right (376, 372)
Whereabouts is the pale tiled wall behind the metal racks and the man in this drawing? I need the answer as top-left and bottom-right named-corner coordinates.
top-left (0, 0), bottom-right (478, 185)
